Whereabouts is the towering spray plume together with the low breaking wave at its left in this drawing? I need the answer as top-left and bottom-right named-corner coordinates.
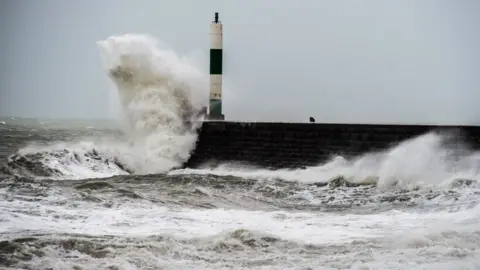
top-left (4, 34), bottom-right (208, 179)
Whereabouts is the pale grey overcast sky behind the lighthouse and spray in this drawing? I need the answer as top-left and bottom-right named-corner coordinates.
top-left (0, 0), bottom-right (480, 124)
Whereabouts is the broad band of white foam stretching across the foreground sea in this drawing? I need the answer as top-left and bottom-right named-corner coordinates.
top-left (0, 190), bottom-right (480, 245)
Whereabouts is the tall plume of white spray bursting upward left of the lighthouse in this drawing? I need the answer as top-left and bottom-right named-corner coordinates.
top-left (98, 34), bottom-right (208, 173)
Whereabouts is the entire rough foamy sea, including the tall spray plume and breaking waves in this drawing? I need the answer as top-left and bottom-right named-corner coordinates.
top-left (0, 35), bottom-right (480, 269)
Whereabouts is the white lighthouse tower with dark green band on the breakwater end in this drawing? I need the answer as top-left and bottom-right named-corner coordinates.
top-left (207, 12), bottom-right (225, 120)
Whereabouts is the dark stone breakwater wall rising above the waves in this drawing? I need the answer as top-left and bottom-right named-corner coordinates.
top-left (183, 121), bottom-right (480, 169)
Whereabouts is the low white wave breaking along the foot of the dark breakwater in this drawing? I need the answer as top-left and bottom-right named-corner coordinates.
top-left (170, 133), bottom-right (480, 190)
